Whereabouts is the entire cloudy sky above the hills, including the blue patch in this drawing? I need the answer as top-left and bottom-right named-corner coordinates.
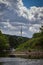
top-left (0, 0), bottom-right (43, 37)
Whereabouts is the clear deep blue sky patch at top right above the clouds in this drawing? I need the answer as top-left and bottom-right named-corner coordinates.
top-left (22, 0), bottom-right (43, 8)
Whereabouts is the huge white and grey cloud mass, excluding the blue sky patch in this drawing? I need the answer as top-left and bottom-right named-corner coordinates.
top-left (0, 0), bottom-right (43, 36)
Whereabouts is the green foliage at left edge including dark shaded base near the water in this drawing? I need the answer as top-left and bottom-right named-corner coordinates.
top-left (0, 31), bottom-right (9, 56)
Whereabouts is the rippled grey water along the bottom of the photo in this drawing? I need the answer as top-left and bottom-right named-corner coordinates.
top-left (0, 58), bottom-right (43, 65)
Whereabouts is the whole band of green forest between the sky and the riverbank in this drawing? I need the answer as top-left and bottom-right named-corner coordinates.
top-left (0, 26), bottom-right (43, 57)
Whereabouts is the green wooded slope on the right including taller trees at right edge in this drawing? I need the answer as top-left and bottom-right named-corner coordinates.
top-left (16, 26), bottom-right (43, 51)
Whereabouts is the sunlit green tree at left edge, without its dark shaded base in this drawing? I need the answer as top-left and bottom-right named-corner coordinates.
top-left (0, 31), bottom-right (9, 51)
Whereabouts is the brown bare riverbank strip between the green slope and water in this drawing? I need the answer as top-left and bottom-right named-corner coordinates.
top-left (9, 51), bottom-right (43, 59)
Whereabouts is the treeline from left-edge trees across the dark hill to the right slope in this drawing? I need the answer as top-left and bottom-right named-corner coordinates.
top-left (0, 31), bottom-right (29, 56)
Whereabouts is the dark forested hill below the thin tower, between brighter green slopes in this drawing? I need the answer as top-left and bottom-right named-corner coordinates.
top-left (4, 34), bottom-right (29, 48)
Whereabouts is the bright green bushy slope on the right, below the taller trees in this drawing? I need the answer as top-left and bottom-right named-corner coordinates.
top-left (16, 37), bottom-right (43, 51)
